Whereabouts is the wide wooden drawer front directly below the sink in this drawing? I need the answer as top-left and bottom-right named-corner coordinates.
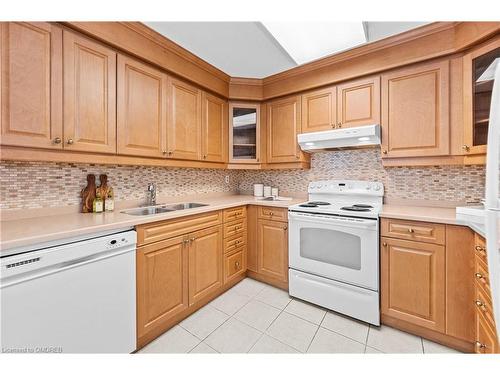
top-left (136, 211), bottom-right (222, 246)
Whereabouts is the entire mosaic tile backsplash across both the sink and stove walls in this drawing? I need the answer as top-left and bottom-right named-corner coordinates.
top-left (0, 149), bottom-right (485, 209)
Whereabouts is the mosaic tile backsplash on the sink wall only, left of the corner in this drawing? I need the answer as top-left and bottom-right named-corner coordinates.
top-left (0, 161), bottom-right (238, 209)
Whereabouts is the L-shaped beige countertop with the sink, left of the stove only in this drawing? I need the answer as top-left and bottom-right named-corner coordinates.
top-left (0, 195), bottom-right (304, 252)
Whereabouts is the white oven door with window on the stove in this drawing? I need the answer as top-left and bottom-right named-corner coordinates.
top-left (288, 212), bottom-right (379, 291)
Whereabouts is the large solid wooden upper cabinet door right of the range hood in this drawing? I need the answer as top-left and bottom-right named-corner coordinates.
top-left (382, 60), bottom-right (450, 157)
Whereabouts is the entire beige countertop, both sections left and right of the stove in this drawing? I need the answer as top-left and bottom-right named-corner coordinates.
top-left (0, 195), bottom-right (480, 252)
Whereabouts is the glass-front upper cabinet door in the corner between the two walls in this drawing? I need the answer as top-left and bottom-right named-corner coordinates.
top-left (229, 103), bottom-right (260, 163)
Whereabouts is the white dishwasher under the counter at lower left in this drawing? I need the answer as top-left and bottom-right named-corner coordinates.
top-left (0, 230), bottom-right (137, 353)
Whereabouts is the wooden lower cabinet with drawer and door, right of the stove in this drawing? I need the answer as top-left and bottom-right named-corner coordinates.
top-left (380, 218), bottom-right (478, 352)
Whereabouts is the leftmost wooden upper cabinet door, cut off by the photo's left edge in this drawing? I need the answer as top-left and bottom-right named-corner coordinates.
top-left (0, 22), bottom-right (63, 149)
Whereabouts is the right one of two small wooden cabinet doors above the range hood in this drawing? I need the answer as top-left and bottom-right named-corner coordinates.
top-left (337, 76), bottom-right (380, 128)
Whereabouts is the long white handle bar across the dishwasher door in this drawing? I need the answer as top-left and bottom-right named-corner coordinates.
top-left (0, 247), bottom-right (135, 289)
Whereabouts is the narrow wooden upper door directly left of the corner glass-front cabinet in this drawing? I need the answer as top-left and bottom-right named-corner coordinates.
top-left (201, 92), bottom-right (228, 163)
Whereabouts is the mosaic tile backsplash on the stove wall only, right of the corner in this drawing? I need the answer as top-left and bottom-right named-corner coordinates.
top-left (239, 149), bottom-right (485, 206)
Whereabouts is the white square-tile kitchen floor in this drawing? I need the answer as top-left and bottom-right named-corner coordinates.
top-left (139, 278), bottom-right (458, 354)
